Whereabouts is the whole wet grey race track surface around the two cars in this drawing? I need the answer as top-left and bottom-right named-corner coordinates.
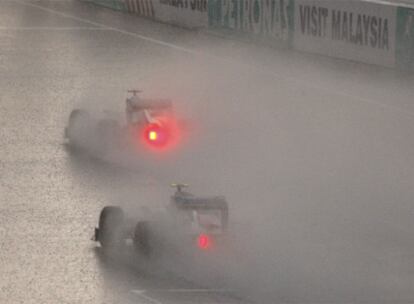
top-left (0, 0), bottom-right (414, 304)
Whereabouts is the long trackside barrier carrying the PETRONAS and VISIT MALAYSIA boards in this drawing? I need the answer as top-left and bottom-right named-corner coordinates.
top-left (82, 0), bottom-right (414, 71)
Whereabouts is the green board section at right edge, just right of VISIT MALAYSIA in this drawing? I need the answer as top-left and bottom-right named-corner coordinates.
top-left (396, 7), bottom-right (414, 70)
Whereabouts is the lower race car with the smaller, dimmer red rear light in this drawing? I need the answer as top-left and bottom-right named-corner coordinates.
top-left (94, 184), bottom-right (229, 257)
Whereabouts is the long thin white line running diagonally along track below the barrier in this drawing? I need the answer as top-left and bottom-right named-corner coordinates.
top-left (15, 0), bottom-right (414, 118)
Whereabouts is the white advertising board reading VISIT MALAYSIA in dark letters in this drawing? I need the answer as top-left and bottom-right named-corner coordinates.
top-left (293, 0), bottom-right (396, 67)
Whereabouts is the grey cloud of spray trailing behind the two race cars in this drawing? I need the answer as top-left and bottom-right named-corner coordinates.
top-left (69, 39), bottom-right (414, 303)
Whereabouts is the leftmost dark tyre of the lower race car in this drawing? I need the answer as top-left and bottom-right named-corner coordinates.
top-left (98, 206), bottom-right (124, 250)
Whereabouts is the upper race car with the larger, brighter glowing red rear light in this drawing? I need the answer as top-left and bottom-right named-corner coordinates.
top-left (65, 89), bottom-right (185, 155)
